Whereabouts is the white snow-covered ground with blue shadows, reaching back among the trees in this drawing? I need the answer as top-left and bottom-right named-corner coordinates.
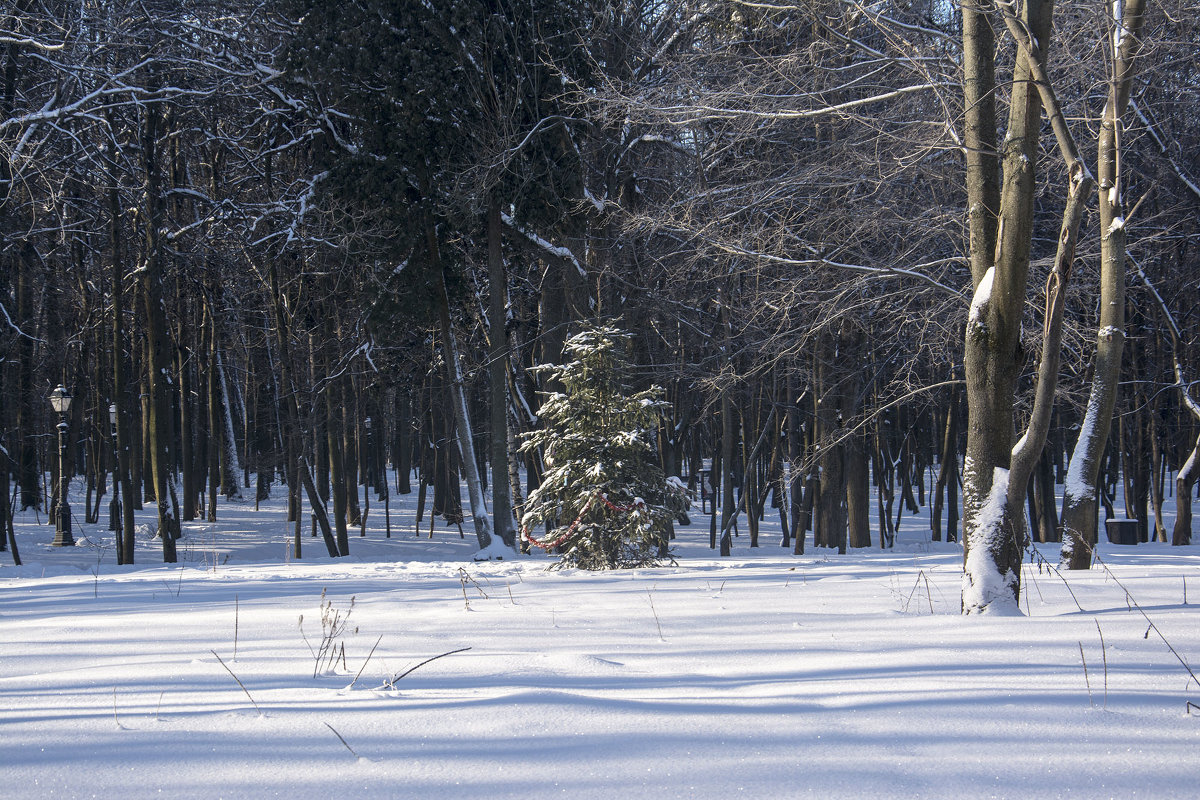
top-left (0, 479), bottom-right (1200, 799)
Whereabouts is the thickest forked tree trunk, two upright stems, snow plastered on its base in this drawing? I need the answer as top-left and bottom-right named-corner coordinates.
top-left (962, 0), bottom-right (1057, 613)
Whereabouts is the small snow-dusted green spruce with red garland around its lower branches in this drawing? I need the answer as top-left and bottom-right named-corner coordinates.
top-left (521, 323), bottom-right (678, 570)
